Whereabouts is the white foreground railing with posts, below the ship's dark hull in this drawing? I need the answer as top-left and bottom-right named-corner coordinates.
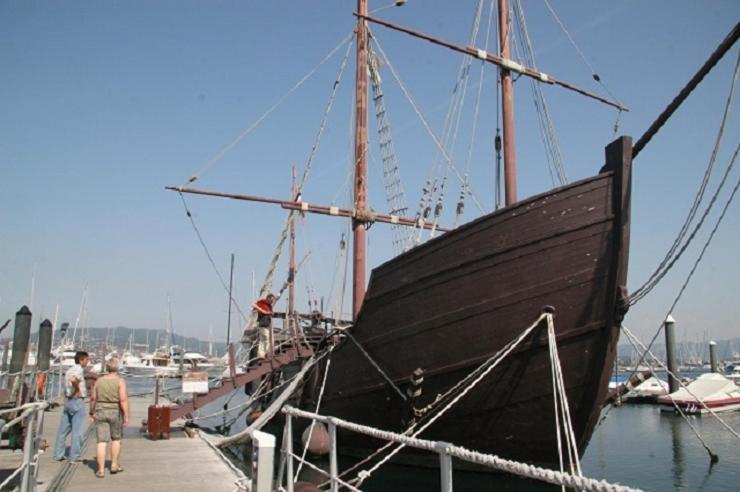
top-left (278, 405), bottom-right (639, 492)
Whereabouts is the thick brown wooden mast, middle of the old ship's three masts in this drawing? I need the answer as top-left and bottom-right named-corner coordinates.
top-left (352, 0), bottom-right (368, 319)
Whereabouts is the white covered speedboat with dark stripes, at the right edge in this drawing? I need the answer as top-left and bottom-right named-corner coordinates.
top-left (658, 373), bottom-right (740, 415)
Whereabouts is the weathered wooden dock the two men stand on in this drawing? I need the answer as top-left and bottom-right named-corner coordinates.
top-left (0, 396), bottom-right (246, 492)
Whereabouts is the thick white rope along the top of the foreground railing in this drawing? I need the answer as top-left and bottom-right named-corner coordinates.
top-left (282, 405), bottom-right (639, 492)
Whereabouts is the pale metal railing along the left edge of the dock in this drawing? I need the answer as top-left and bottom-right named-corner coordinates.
top-left (0, 401), bottom-right (49, 492)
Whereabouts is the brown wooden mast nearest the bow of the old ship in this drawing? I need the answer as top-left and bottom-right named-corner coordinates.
top-left (498, 0), bottom-right (517, 206)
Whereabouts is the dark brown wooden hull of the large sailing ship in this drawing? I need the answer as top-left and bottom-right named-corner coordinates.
top-left (304, 137), bottom-right (631, 464)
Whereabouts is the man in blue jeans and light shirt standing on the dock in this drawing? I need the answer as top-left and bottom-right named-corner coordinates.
top-left (54, 352), bottom-right (90, 461)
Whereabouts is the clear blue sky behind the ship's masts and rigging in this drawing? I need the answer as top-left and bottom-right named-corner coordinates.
top-left (0, 0), bottom-right (740, 341)
